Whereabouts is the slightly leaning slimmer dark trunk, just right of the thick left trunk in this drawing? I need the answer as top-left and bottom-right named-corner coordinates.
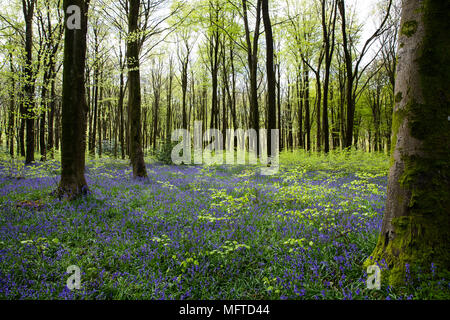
top-left (127, 0), bottom-right (147, 178)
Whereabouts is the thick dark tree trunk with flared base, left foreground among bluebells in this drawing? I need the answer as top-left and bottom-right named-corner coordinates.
top-left (58, 0), bottom-right (89, 199)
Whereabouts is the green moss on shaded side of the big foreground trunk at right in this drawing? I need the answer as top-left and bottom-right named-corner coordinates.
top-left (364, 0), bottom-right (450, 286)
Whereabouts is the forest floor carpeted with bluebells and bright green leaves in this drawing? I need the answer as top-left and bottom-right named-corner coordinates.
top-left (0, 152), bottom-right (450, 299)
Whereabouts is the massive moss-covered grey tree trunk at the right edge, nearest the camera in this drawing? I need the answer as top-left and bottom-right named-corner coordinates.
top-left (365, 0), bottom-right (450, 285)
